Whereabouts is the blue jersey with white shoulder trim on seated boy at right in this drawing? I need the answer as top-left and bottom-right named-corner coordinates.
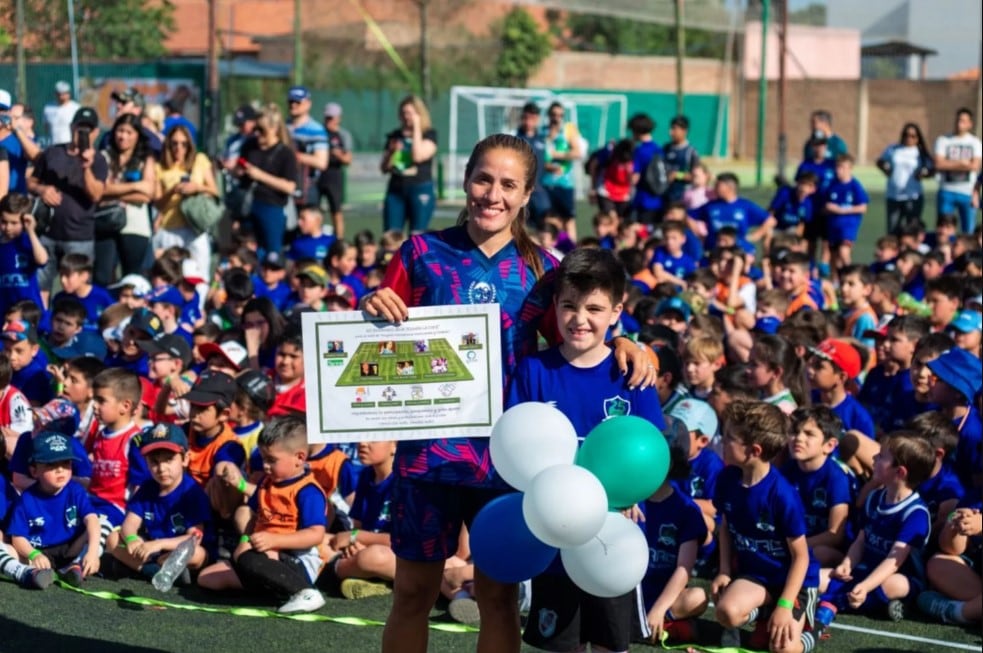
top-left (860, 488), bottom-right (932, 576)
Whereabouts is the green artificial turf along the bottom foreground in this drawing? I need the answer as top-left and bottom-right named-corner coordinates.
top-left (0, 578), bottom-right (981, 653)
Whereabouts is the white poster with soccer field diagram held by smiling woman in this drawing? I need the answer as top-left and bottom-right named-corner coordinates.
top-left (303, 304), bottom-right (502, 443)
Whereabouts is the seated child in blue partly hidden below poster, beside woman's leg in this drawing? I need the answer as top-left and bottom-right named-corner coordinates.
top-left (322, 441), bottom-right (396, 599)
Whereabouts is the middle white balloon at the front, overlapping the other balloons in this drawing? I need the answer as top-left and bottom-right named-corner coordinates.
top-left (522, 465), bottom-right (608, 548)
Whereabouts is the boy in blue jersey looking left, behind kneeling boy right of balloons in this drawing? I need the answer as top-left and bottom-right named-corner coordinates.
top-left (782, 406), bottom-right (852, 567)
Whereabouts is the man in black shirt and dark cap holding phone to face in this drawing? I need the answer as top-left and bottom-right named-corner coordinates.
top-left (27, 107), bottom-right (109, 300)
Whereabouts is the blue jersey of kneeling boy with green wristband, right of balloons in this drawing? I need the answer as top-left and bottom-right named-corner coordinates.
top-left (713, 466), bottom-right (819, 588)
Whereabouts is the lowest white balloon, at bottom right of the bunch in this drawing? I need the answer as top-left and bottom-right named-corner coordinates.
top-left (560, 512), bottom-right (649, 597)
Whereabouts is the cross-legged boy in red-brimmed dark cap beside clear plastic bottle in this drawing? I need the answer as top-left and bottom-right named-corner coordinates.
top-left (106, 424), bottom-right (211, 578)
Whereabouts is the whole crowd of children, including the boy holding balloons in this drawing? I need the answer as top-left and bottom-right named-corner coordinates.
top-left (0, 103), bottom-right (983, 652)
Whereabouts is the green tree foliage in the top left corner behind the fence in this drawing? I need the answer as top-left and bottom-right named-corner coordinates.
top-left (25, 0), bottom-right (175, 60)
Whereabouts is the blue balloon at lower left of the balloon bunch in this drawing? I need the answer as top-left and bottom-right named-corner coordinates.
top-left (471, 492), bottom-right (559, 583)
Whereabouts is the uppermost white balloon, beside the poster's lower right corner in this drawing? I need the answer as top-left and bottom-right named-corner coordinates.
top-left (489, 401), bottom-right (577, 492)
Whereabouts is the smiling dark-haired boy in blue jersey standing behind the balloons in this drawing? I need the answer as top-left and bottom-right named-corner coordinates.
top-left (505, 248), bottom-right (665, 651)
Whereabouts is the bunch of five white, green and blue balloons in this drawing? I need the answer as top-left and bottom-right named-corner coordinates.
top-left (471, 402), bottom-right (669, 597)
